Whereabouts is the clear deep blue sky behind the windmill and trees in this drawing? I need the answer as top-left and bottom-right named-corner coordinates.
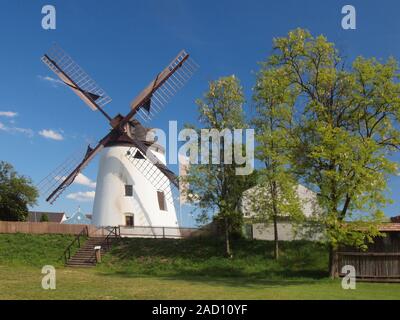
top-left (0, 0), bottom-right (400, 222)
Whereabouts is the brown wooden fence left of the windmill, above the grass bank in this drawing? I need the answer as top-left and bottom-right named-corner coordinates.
top-left (0, 221), bottom-right (96, 235)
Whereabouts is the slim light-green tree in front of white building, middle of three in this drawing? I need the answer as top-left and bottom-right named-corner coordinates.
top-left (249, 65), bottom-right (302, 259)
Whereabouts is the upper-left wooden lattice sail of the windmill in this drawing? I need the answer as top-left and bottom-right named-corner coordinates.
top-left (42, 45), bottom-right (111, 116)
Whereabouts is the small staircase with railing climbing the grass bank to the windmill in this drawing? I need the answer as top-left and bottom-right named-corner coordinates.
top-left (66, 237), bottom-right (108, 268)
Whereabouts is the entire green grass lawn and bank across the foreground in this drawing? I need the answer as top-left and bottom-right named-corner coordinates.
top-left (0, 234), bottom-right (400, 299)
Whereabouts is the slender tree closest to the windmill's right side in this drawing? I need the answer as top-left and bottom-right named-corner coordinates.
top-left (184, 76), bottom-right (252, 257)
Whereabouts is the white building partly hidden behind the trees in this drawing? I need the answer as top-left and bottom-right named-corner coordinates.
top-left (241, 184), bottom-right (321, 241)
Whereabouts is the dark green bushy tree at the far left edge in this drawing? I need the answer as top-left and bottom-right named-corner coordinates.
top-left (0, 161), bottom-right (38, 221)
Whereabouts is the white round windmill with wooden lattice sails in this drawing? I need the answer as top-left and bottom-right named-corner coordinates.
top-left (38, 46), bottom-right (197, 235)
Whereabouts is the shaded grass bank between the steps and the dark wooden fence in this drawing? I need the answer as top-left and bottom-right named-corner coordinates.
top-left (93, 238), bottom-right (328, 287)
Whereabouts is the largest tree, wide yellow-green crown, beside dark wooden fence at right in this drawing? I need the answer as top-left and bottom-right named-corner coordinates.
top-left (266, 29), bottom-right (400, 276)
